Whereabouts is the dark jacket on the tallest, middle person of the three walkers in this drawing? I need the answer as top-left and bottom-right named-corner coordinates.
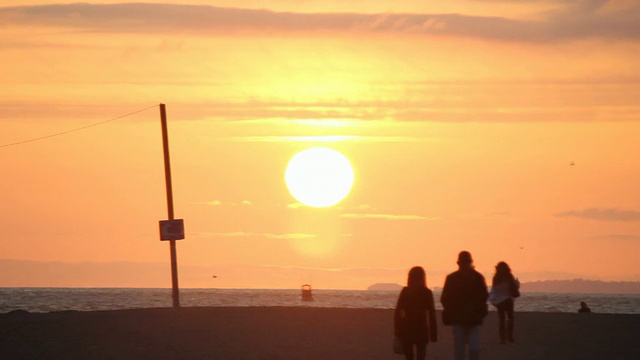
top-left (440, 268), bottom-right (489, 326)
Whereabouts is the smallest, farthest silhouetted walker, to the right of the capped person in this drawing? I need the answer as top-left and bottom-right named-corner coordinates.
top-left (489, 261), bottom-right (520, 344)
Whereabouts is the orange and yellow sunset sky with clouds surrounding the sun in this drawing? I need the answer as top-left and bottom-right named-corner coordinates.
top-left (0, 0), bottom-right (640, 289)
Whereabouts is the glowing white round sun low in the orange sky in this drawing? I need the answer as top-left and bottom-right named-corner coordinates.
top-left (284, 147), bottom-right (354, 208)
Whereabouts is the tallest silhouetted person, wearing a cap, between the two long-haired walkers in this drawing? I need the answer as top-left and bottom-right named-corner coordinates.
top-left (440, 251), bottom-right (488, 360)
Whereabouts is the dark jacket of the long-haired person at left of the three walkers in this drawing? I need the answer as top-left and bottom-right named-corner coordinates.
top-left (394, 286), bottom-right (438, 343)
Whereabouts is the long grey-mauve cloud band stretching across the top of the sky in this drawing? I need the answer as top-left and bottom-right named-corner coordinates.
top-left (0, 0), bottom-right (640, 42)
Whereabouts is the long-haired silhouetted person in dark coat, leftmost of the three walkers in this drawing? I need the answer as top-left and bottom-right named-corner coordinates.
top-left (394, 266), bottom-right (438, 360)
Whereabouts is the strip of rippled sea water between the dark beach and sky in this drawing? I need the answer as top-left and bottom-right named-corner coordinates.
top-left (0, 288), bottom-right (640, 314)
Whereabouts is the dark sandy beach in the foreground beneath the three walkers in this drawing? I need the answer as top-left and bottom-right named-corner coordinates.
top-left (0, 307), bottom-right (640, 360)
